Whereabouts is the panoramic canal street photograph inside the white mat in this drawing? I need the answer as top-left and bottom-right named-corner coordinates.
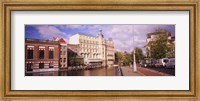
top-left (24, 24), bottom-right (175, 76)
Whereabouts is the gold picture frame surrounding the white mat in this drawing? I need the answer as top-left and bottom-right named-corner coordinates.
top-left (0, 0), bottom-right (200, 101)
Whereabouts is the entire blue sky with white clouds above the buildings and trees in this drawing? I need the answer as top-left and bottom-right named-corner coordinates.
top-left (25, 24), bottom-right (175, 52)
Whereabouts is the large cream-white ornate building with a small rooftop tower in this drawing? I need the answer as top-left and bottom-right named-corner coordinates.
top-left (69, 30), bottom-right (115, 66)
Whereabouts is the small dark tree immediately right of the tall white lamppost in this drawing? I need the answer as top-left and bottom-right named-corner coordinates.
top-left (135, 47), bottom-right (144, 63)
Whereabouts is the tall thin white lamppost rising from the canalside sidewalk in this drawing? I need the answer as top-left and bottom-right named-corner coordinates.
top-left (132, 25), bottom-right (137, 72)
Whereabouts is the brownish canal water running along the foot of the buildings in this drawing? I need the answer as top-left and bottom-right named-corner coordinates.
top-left (25, 67), bottom-right (122, 76)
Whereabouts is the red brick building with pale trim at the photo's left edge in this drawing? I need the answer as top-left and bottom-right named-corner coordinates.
top-left (25, 39), bottom-right (60, 72)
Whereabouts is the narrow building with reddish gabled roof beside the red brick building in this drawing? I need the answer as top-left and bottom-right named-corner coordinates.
top-left (53, 38), bottom-right (68, 69)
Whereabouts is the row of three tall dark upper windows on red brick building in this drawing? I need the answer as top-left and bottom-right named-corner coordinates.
top-left (27, 50), bottom-right (54, 59)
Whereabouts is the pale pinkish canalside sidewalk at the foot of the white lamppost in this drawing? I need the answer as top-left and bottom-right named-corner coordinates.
top-left (121, 66), bottom-right (143, 76)
